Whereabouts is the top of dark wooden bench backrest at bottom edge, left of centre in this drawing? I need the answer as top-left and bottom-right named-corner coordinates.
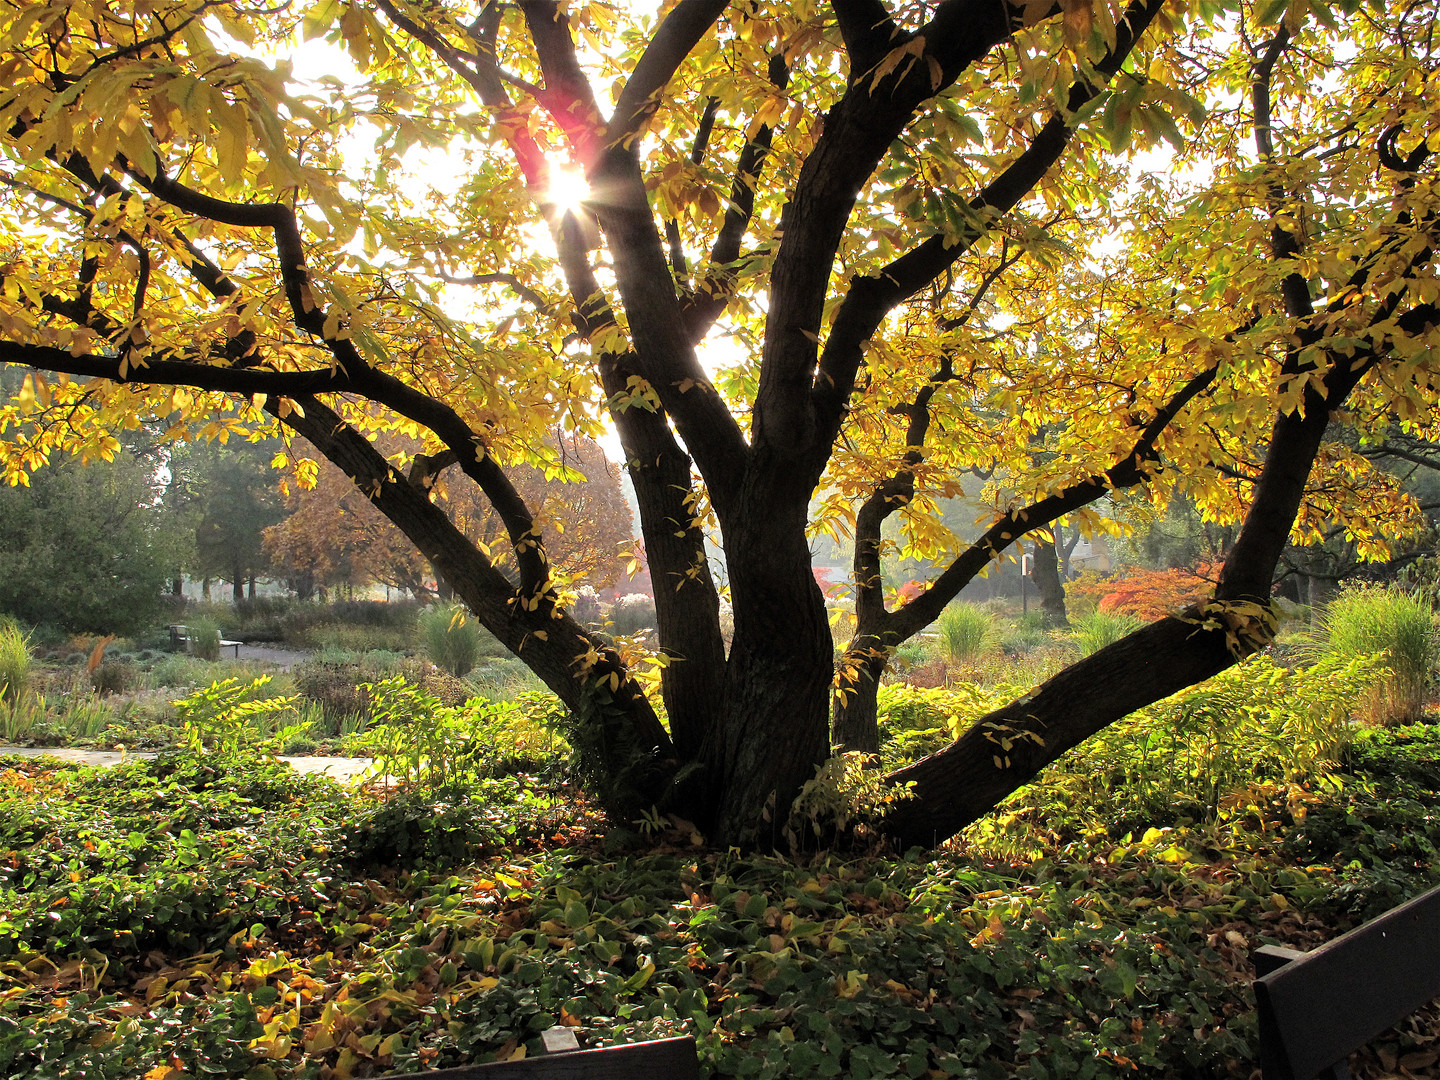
top-left (387, 1028), bottom-right (700, 1080)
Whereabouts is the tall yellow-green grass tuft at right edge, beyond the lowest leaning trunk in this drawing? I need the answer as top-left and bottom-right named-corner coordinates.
top-left (1318, 586), bottom-right (1437, 727)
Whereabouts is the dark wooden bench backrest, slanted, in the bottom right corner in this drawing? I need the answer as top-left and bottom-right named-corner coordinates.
top-left (1254, 888), bottom-right (1440, 1080)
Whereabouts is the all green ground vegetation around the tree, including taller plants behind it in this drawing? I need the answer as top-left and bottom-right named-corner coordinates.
top-left (0, 587), bottom-right (1440, 1080)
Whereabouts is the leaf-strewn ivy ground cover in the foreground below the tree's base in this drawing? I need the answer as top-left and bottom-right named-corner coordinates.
top-left (0, 726), bottom-right (1440, 1080)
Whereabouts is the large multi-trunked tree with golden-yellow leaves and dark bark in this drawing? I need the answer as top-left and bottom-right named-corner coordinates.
top-left (0, 0), bottom-right (1440, 844)
